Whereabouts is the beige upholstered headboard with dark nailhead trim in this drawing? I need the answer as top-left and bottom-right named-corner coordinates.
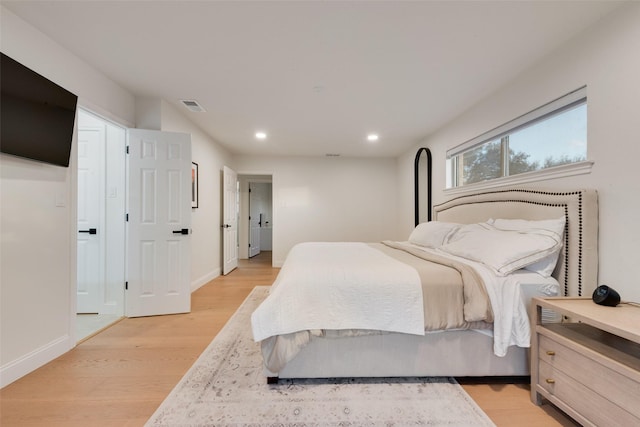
top-left (433, 188), bottom-right (598, 296)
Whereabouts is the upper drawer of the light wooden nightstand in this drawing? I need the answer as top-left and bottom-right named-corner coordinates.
top-left (538, 334), bottom-right (640, 420)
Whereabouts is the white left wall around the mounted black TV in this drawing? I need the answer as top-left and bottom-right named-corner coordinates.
top-left (0, 6), bottom-right (135, 386)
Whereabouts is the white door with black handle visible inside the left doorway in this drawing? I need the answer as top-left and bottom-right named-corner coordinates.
top-left (76, 128), bottom-right (105, 313)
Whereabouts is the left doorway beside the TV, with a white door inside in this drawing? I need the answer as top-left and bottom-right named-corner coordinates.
top-left (75, 108), bottom-right (126, 341)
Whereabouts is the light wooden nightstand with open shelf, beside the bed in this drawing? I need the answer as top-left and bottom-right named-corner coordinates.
top-left (531, 297), bottom-right (640, 426)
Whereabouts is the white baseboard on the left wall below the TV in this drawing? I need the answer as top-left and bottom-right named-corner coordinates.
top-left (0, 335), bottom-right (75, 388)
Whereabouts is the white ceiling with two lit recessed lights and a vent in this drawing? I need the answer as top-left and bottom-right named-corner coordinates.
top-left (2, 0), bottom-right (621, 156)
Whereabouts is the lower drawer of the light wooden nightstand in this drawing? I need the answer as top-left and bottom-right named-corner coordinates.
top-left (538, 361), bottom-right (640, 426)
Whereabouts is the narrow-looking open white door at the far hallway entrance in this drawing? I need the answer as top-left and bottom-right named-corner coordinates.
top-left (222, 166), bottom-right (238, 274)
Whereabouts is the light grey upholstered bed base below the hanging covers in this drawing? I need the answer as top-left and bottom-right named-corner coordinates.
top-left (264, 331), bottom-right (529, 381)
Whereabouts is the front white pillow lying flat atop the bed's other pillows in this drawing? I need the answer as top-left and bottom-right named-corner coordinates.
top-left (440, 223), bottom-right (562, 276)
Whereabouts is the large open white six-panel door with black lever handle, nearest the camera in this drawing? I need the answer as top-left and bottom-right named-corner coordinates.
top-left (126, 129), bottom-right (191, 317)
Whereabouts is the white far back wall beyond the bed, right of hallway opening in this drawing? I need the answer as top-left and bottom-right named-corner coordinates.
top-left (234, 156), bottom-right (398, 266)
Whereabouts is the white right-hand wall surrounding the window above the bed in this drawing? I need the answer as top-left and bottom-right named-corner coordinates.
top-left (398, 2), bottom-right (640, 301)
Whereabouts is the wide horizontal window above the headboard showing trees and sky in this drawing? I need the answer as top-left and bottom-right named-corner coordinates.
top-left (447, 87), bottom-right (587, 188)
